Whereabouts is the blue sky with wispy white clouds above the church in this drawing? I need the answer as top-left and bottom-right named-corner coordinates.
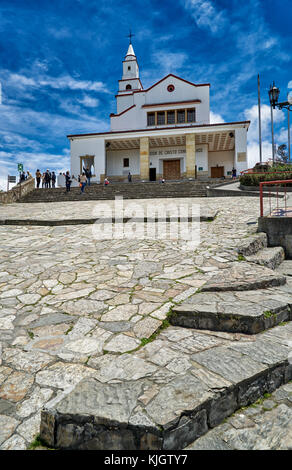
top-left (0, 0), bottom-right (292, 187)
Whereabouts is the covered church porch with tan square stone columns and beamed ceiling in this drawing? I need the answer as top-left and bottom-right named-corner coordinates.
top-left (105, 130), bottom-right (241, 181)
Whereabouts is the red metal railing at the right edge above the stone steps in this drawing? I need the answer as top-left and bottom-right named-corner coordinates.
top-left (260, 180), bottom-right (292, 217)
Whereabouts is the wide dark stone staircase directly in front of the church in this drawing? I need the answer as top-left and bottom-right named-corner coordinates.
top-left (19, 180), bottom-right (216, 203)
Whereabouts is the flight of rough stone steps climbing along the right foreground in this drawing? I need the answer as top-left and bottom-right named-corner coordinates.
top-left (40, 234), bottom-right (292, 450)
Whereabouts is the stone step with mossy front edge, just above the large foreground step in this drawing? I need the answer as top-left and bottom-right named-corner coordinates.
top-left (170, 289), bottom-right (292, 334)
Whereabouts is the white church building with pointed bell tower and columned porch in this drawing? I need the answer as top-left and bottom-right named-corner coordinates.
top-left (68, 43), bottom-right (250, 183)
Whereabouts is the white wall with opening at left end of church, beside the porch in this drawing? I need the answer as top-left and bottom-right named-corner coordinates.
top-left (70, 137), bottom-right (105, 183)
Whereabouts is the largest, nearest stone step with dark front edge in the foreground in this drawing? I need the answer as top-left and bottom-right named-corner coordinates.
top-left (36, 323), bottom-right (292, 450)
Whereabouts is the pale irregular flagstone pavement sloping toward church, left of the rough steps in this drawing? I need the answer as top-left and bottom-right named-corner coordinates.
top-left (0, 197), bottom-right (290, 449)
